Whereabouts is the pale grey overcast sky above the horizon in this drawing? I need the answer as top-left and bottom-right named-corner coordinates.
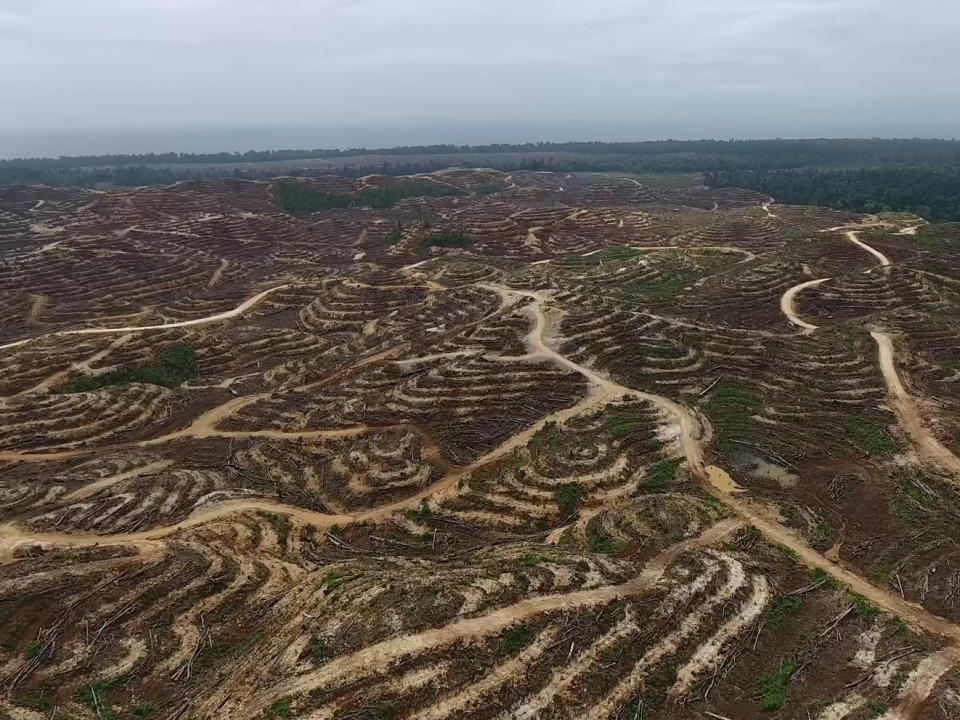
top-left (0, 0), bottom-right (960, 157)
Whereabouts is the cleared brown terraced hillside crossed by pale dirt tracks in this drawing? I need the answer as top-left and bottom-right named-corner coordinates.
top-left (0, 170), bottom-right (960, 720)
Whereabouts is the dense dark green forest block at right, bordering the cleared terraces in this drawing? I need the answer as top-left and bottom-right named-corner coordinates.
top-left (705, 166), bottom-right (960, 222)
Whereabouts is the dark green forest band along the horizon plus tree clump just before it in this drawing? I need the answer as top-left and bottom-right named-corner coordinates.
top-left (0, 139), bottom-right (960, 222)
